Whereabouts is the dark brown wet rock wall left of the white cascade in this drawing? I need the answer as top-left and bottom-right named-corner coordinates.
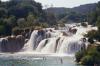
top-left (0, 35), bottom-right (25, 52)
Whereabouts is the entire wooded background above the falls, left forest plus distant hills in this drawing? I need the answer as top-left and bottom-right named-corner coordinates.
top-left (0, 0), bottom-right (96, 36)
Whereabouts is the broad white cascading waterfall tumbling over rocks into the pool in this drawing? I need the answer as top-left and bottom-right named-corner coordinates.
top-left (0, 24), bottom-right (97, 54)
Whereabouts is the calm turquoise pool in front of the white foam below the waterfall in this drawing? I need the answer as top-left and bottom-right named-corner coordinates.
top-left (0, 57), bottom-right (81, 66)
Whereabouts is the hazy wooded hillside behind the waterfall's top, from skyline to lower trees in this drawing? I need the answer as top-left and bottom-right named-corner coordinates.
top-left (45, 3), bottom-right (96, 22)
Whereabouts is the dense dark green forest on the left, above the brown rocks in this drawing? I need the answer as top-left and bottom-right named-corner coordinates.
top-left (0, 0), bottom-right (56, 36)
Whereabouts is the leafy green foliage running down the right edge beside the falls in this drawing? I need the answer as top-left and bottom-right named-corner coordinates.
top-left (79, 2), bottom-right (100, 66)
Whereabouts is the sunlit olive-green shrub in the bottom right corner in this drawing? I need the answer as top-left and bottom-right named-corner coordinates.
top-left (80, 45), bottom-right (100, 65)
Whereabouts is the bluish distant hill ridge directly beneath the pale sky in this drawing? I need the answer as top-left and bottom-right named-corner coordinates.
top-left (46, 3), bottom-right (96, 15)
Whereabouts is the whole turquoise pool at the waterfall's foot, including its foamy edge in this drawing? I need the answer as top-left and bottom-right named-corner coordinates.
top-left (0, 54), bottom-right (83, 66)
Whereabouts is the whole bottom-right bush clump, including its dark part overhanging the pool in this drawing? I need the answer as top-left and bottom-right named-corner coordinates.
top-left (76, 44), bottom-right (100, 66)
